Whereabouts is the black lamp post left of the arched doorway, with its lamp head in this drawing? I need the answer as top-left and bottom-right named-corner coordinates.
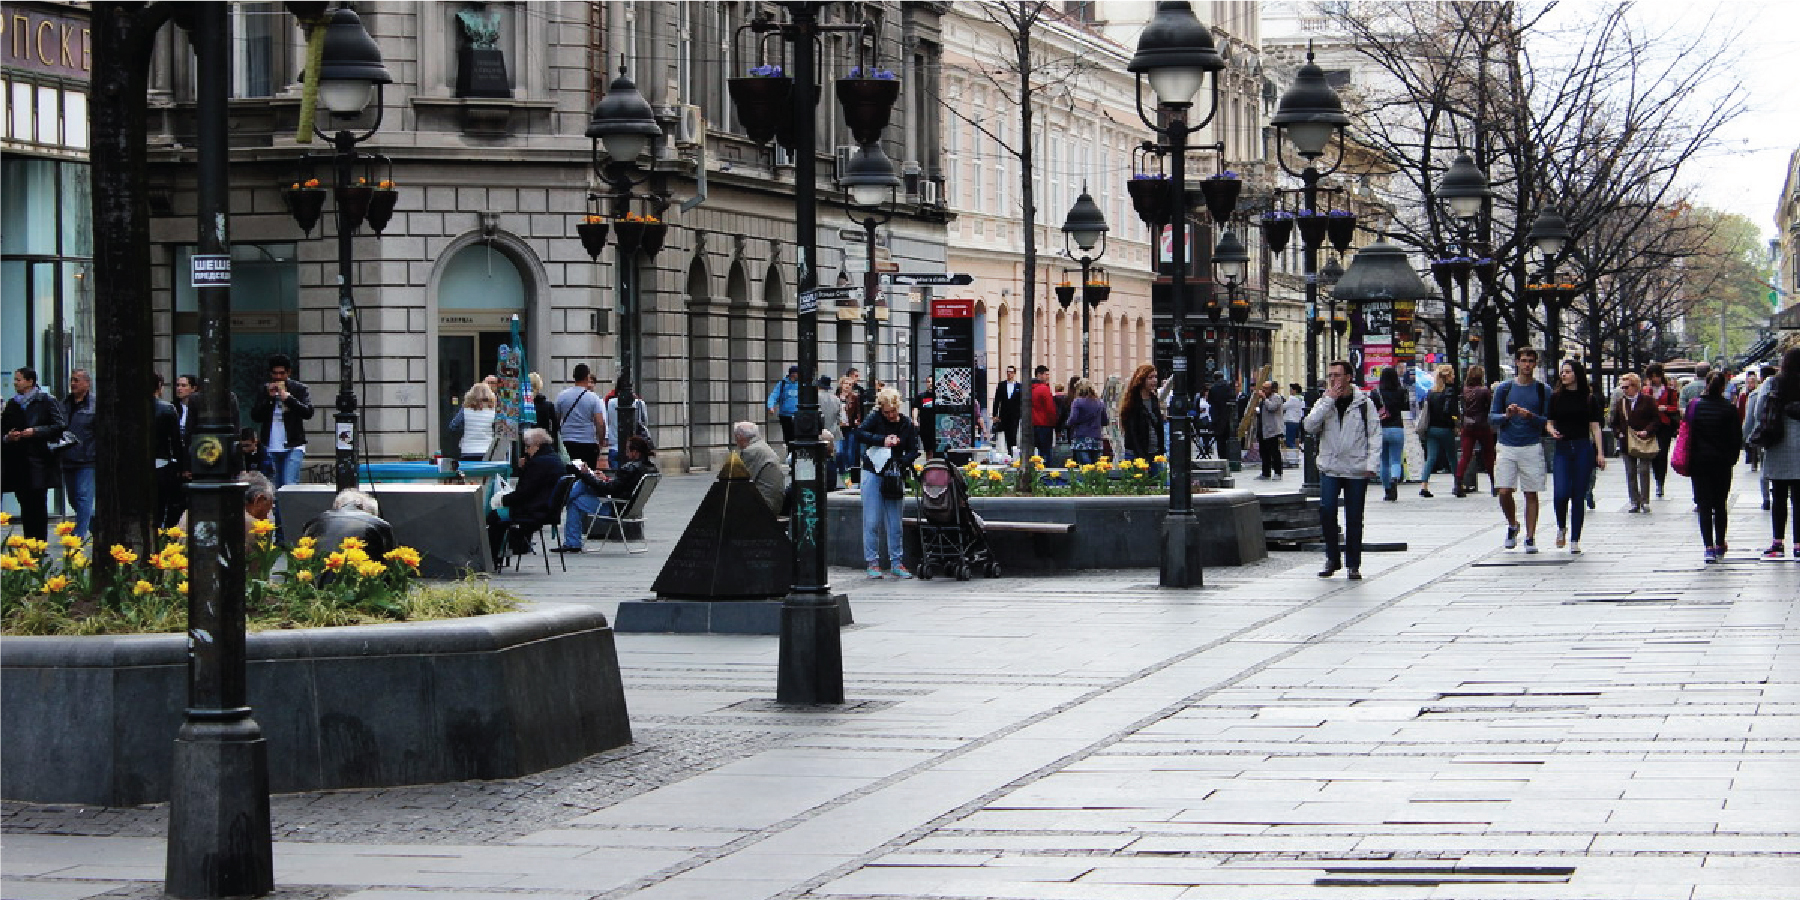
top-left (313, 5), bottom-right (394, 491)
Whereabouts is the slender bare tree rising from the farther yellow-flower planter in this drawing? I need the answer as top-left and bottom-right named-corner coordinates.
top-left (927, 0), bottom-right (1094, 491)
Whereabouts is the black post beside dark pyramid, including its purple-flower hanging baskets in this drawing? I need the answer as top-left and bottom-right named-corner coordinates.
top-left (733, 0), bottom-right (900, 704)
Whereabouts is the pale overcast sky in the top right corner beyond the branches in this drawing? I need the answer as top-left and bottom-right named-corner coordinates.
top-left (1620, 0), bottom-right (1800, 238)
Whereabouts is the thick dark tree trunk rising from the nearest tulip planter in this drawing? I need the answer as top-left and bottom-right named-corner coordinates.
top-left (88, 2), bottom-right (169, 569)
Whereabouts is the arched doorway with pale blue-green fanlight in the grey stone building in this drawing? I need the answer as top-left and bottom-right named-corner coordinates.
top-left (430, 238), bottom-right (544, 452)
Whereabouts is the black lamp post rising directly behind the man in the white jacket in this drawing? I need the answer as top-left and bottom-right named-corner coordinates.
top-left (1269, 45), bottom-right (1350, 491)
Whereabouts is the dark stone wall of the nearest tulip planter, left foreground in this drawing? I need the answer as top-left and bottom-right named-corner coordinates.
top-left (0, 607), bottom-right (632, 806)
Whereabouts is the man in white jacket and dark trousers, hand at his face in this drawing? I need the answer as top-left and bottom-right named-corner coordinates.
top-left (1303, 362), bottom-right (1381, 581)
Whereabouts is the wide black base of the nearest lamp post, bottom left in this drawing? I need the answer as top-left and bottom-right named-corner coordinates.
top-left (162, 715), bottom-right (275, 900)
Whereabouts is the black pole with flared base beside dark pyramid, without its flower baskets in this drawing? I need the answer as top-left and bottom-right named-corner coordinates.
top-left (776, 2), bottom-right (844, 704)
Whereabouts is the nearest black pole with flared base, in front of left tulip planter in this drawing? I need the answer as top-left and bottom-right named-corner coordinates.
top-left (164, 4), bottom-right (275, 898)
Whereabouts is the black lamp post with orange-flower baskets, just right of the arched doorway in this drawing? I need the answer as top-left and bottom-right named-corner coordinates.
top-left (581, 65), bottom-right (668, 459)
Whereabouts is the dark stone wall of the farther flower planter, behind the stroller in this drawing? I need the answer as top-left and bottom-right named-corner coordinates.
top-left (826, 490), bottom-right (1269, 571)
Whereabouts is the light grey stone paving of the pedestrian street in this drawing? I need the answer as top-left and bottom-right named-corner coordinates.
top-left (0, 466), bottom-right (1800, 900)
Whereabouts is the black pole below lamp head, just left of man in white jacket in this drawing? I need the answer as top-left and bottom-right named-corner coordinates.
top-left (1161, 103), bottom-right (1201, 587)
